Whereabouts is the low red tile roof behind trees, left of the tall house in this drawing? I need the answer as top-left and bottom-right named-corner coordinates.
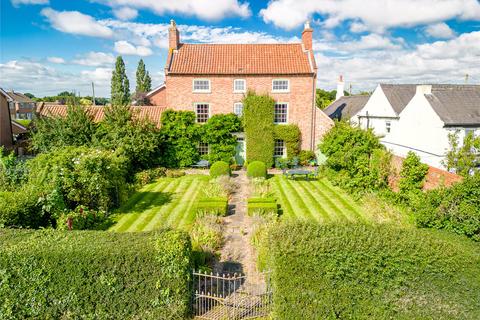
top-left (37, 104), bottom-right (167, 127)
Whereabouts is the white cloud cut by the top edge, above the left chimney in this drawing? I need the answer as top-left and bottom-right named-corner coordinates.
top-left (92, 0), bottom-right (251, 20)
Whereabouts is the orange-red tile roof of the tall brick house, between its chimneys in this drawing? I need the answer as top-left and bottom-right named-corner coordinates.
top-left (167, 43), bottom-right (314, 74)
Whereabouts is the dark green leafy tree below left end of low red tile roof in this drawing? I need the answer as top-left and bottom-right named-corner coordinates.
top-left (31, 106), bottom-right (97, 152)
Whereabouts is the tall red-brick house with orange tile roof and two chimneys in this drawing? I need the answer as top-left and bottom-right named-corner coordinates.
top-left (147, 20), bottom-right (333, 162)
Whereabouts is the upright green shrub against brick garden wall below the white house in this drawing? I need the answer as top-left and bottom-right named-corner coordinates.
top-left (398, 151), bottom-right (428, 195)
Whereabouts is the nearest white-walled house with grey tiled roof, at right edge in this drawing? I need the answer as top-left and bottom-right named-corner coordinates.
top-left (382, 84), bottom-right (480, 169)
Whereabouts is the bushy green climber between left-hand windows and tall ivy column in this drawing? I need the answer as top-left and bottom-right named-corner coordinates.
top-left (198, 114), bottom-right (241, 163)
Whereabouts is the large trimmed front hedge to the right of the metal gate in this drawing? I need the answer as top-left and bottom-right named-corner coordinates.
top-left (261, 223), bottom-right (480, 319)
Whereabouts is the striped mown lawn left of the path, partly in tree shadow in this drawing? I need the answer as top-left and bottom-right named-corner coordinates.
top-left (109, 175), bottom-right (209, 232)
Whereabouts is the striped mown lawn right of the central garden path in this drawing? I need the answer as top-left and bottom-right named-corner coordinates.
top-left (270, 175), bottom-right (373, 223)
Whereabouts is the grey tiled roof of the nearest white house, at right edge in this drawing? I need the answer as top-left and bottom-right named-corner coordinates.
top-left (425, 84), bottom-right (480, 126)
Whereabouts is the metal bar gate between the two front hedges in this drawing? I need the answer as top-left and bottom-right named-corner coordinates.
top-left (193, 272), bottom-right (272, 320)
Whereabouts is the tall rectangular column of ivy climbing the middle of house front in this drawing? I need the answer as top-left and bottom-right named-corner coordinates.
top-left (243, 91), bottom-right (275, 167)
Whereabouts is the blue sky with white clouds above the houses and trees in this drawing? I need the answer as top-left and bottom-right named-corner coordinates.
top-left (0, 0), bottom-right (480, 96)
